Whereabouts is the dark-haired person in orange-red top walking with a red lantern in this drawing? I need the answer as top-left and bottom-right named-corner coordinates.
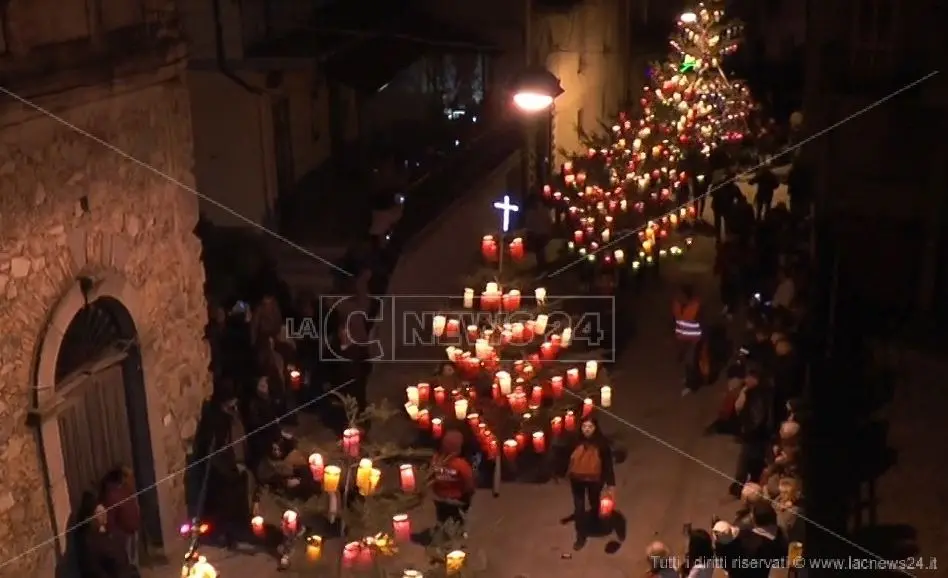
top-left (561, 417), bottom-right (616, 550)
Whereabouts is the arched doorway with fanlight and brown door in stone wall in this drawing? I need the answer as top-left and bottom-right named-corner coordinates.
top-left (38, 295), bottom-right (162, 546)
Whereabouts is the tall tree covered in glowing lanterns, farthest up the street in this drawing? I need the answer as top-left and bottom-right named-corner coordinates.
top-left (544, 0), bottom-right (754, 278)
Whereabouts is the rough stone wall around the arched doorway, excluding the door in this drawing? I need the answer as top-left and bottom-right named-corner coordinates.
top-left (0, 78), bottom-right (210, 576)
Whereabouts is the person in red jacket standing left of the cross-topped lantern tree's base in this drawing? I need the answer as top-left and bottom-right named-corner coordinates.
top-left (431, 430), bottom-right (475, 532)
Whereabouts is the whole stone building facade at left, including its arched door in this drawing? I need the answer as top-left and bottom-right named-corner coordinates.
top-left (0, 2), bottom-right (210, 576)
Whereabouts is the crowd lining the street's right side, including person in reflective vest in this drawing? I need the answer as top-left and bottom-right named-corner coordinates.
top-left (646, 154), bottom-right (810, 578)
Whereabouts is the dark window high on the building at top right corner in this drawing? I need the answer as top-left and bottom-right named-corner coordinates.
top-left (851, 0), bottom-right (898, 72)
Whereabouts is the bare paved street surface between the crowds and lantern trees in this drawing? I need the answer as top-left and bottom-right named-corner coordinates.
top-left (163, 167), bottom-right (792, 578)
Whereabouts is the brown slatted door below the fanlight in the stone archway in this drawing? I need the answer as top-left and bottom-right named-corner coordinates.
top-left (58, 363), bottom-right (135, 508)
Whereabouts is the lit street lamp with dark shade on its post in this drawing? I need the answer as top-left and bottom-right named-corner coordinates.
top-left (513, 67), bottom-right (564, 205)
